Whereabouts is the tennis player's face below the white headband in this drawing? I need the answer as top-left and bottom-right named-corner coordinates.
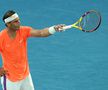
top-left (8, 18), bottom-right (20, 30)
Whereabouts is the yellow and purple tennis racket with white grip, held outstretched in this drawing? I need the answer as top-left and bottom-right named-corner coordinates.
top-left (61, 10), bottom-right (101, 32)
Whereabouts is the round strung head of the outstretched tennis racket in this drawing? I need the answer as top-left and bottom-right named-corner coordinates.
top-left (78, 10), bottom-right (101, 32)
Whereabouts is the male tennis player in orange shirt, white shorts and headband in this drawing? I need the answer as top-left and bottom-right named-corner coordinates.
top-left (0, 10), bottom-right (64, 90)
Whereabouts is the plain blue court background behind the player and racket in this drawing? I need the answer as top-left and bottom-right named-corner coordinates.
top-left (0, 0), bottom-right (108, 90)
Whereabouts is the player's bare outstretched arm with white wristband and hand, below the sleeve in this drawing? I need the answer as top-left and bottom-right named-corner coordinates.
top-left (30, 24), bottom-right (64, 37)
